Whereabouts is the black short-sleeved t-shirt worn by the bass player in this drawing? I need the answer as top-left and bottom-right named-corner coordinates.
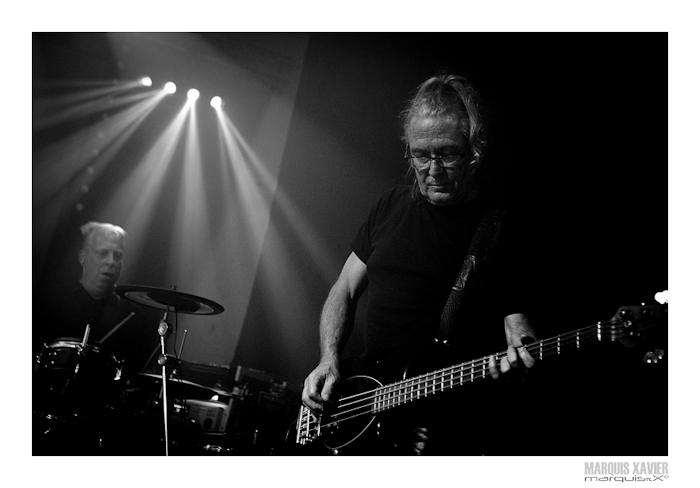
top-left (352, 185), bottom-right (524, 360)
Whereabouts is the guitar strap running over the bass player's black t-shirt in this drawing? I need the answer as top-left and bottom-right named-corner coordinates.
top-left (439, 208), bottom-right (504, 343)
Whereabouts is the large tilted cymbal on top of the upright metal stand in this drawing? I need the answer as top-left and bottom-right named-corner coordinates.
top-left (115, 285), bottom-right (224, 315)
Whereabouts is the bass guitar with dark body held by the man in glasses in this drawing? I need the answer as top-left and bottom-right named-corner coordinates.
top-left (296, 303), bottom-right (668, 454)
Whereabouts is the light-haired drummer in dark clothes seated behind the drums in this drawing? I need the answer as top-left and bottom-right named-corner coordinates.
top-left (32, 222), bottom-right (159, 375)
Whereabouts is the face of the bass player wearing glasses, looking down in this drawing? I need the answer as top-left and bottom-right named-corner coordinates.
top-left (406, 117), bottom-right (474, 205)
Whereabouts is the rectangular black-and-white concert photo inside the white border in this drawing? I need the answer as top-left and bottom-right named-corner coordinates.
top-left (15, 13), bottom-right (692, 486)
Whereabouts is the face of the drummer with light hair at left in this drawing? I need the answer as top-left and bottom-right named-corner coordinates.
top-left (80, 232), bottom-right (124, 298)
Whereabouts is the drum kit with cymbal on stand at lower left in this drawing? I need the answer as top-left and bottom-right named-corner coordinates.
top-left (32, 285), bottom-right (266, 456)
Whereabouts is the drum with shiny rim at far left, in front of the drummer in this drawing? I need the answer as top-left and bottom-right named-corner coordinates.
top-left (33, 338), bottom-right (123, 413)
